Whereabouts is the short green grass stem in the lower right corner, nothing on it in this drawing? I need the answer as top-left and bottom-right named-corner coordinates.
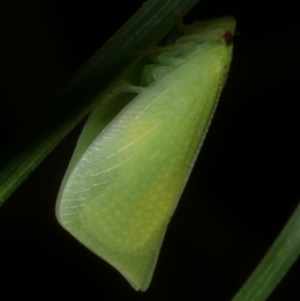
top-left (232, 200), bottom-right (300, 301)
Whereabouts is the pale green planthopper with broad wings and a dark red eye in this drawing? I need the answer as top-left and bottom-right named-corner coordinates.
top-left (56, 17), bottom-right (235, 291)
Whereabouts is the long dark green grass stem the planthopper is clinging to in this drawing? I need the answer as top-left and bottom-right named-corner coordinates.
top-left (0, 0), bottom-right (200, 206)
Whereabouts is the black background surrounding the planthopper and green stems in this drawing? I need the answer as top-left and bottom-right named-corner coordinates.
top-left (0, 0), bottom-right (300, 301)
